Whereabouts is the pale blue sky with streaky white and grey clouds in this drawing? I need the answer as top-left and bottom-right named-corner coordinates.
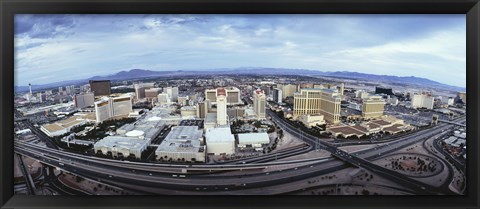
top-left (15, 14), bottom-right (466, 87)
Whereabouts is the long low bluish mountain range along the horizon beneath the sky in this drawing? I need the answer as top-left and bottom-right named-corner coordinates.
top-left (15, 67), bottom-right (465, 92)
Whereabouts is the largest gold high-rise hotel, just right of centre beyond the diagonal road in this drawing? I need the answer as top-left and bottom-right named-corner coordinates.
top-left (293, 88), bottom-right (341, 123)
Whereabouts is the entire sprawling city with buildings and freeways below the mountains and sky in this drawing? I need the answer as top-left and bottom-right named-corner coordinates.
top-left (14, 73), bottom-right (467, 195)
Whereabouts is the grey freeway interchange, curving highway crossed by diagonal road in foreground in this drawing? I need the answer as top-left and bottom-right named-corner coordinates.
top-left (14, 111), bottom-right (465, 195)
